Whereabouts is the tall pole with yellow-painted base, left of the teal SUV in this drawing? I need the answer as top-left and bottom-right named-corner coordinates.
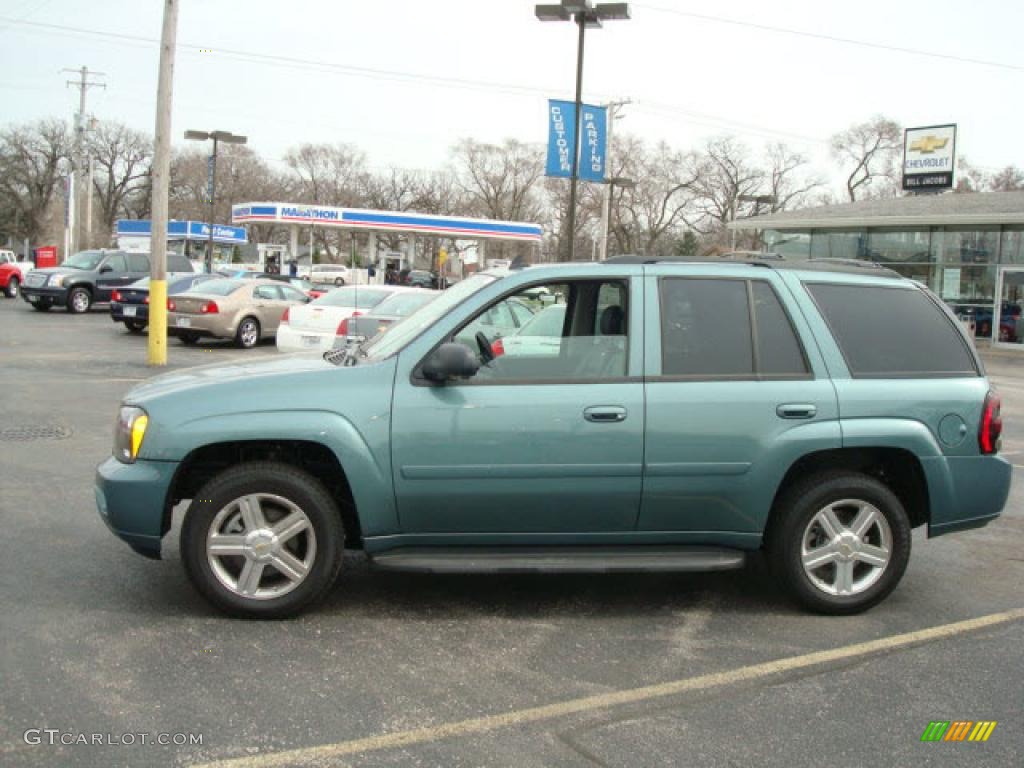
top-left (148, 0), bottom-right (180, 366)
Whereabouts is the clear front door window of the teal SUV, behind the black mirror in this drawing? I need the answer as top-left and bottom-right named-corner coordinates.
top-left (453, 280), bottom-right (629, 384)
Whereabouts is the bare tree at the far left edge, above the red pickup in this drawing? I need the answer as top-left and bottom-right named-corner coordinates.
top-left (0, 120), bottom-right (71, 247)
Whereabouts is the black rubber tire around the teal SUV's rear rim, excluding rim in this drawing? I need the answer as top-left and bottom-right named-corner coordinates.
top-left (765, 472), bottom-right (911, 615)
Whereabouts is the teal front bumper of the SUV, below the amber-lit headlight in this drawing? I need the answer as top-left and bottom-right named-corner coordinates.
top-left (94, 456), bottom-right (178, 557)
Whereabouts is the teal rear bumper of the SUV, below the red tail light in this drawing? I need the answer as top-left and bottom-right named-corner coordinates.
top-left (922, 456), bottom-right (1014, 537)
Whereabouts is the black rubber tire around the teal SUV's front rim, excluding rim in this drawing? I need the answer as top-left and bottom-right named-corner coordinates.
top-left (181, 462), bottom-right (345, 618)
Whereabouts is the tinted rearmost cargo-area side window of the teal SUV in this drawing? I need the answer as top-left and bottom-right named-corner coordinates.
top-left (807, 283), bottom-right (978, 377)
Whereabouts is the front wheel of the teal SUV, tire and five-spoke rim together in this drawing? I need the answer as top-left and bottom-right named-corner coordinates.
top-left (181, 462), bottom-right (344, 618)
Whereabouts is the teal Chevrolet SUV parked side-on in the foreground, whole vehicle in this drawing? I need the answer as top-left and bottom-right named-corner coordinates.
top-left (95, 258), bottom-right (1011, 617)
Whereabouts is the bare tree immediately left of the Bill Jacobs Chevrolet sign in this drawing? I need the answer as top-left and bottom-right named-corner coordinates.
top-left (831, 115), bottom-right (903, 203)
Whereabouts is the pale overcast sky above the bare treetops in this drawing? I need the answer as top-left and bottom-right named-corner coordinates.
top-left (0, 0), bottom-right (1024, 191)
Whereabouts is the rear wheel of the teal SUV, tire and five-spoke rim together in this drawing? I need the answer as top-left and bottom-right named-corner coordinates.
top-left (766, 472), bottom-right (910, 614)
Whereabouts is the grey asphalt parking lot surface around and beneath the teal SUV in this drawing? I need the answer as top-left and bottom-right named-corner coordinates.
top-left (0, 300), bottom-right (1024, 768)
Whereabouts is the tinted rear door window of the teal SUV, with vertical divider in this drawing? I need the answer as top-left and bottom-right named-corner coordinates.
top-left (662, 278), bottom-right (809, 379)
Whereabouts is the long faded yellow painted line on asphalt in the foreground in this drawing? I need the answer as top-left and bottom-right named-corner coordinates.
top-left (193, 608), bottom-right (1024, 768)
